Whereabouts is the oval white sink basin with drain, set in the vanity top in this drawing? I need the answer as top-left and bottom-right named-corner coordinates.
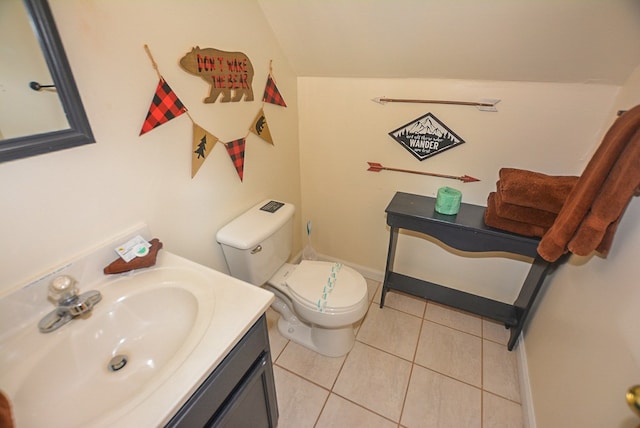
top-left (13, 268), bottom-right (214, 426)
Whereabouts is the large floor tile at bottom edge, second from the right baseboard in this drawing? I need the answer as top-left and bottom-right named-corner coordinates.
top-left (400, 366), bottom-right (482, 428)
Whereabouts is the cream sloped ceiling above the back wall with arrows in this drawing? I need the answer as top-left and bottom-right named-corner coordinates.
top-left (258, 0), bottom-right (640, 85)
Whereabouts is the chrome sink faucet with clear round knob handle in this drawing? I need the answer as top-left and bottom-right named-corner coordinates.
top-left (38, 275), bottom-right (102, 333)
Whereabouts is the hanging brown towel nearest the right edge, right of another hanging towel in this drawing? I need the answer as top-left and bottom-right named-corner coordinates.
top-left (568, 125), bottom-right (640, 256)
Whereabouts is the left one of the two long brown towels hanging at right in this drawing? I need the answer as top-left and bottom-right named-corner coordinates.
top-left (538, 105), bottom-right (640, 262)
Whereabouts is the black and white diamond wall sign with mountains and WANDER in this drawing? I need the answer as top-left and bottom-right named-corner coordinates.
top-left (389, 113), bottom-right (464, 161)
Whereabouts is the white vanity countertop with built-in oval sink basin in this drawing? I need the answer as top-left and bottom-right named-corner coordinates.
top-left (0, 252), bottom-right (272, 428)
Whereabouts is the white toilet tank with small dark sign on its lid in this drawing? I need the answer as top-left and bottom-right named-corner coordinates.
top-left (216, 199), bottom-right (295, 285)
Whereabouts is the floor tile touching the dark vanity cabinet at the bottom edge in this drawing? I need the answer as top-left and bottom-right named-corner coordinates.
top-left (273, 366), bottom-right (329, 428)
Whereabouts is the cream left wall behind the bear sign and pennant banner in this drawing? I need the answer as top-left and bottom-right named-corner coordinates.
top-left (0, 0), bottom-right (300, 294)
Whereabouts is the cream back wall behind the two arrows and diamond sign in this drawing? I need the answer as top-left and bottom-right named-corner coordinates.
top-left (298, 78), bottom-right (618, 302)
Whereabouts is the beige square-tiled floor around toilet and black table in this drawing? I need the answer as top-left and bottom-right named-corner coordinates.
top-left (267, 280), bottom-right (523, 428)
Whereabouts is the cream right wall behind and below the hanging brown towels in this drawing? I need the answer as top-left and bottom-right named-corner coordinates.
top-left (525, 68), bottom-right (640, 428)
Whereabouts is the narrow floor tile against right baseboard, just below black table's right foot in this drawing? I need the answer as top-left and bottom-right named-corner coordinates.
top-left (482, 340), bottom-right (520, 403)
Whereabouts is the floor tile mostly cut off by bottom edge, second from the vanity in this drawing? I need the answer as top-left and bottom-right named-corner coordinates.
top-left (315, 394), bottom-right (397, 428)
